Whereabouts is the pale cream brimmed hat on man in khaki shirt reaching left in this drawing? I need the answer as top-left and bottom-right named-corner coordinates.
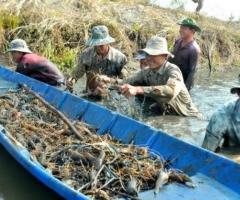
top-left (139, 36), bottom-right (174, 57)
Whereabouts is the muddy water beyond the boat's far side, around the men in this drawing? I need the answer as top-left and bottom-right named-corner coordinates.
top-left (75, 68), bottom-right (240, 161)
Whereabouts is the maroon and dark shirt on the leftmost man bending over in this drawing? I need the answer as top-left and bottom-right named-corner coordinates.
top-left (16, 53), bottom-right (64, 86)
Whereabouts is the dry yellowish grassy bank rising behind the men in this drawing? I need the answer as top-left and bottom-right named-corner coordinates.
top-left (0, 0), bottom-right (240, 71)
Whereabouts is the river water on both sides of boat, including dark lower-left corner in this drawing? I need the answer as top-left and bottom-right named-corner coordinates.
top-left (0, 57), bottom-right (240, 200)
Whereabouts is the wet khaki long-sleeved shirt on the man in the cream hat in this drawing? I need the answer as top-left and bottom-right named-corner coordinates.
top-left (126, 62), bottom-right (201, 116)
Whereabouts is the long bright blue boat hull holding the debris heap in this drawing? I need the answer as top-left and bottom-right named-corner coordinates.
top-left (0, 66), bottom-right (240, 200)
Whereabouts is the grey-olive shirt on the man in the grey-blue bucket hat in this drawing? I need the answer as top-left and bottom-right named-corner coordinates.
top-left (72, 47), bottom-right (127, 79)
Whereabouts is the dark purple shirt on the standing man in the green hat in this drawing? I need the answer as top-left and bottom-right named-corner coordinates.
top-left (170, 38), bottom-right (201, 90)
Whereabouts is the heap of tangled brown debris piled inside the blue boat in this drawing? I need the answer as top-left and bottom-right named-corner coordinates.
top-left (0, 88), bottom-right (194, 199)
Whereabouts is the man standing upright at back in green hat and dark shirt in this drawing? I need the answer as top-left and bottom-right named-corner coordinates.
top-left (169, 18), bottom-right (201, 91)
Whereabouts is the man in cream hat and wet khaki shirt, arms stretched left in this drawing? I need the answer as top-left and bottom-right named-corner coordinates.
top-left (120, 36), bottom-right (201, 116)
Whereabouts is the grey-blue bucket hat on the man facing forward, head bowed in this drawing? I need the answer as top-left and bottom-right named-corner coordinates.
top-left (86, 25), bottom-right (115, 46)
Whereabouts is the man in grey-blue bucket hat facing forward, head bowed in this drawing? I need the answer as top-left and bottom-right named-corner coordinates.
top-left (72, 25), bottom-right (127, 94)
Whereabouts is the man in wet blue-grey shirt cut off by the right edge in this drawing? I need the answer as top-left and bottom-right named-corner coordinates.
top-left (202, 85), bottom-right (240, 151)
